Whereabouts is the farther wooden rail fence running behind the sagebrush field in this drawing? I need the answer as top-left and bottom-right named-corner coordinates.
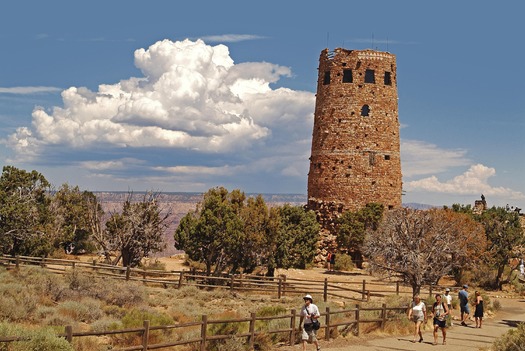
top-left (0, 255), bottom-right (454, 302)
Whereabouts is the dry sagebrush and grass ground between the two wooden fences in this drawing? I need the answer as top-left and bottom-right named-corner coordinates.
top-left (0, 260), bottom-right (420, 351)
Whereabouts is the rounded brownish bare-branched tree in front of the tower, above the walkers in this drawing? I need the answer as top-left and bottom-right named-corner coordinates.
top-left (364, 209), bottom-right (486, 294)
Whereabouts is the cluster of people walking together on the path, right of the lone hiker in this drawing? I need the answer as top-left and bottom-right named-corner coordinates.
top-left (408, 285), bottom-right (483, 345)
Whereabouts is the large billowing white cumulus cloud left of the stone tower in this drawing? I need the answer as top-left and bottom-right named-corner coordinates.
top-left (7, 40), bottom-right (315, 159)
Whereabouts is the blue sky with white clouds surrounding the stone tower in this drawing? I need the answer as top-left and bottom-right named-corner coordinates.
top-left (0, 0), bottom-right (525, 208)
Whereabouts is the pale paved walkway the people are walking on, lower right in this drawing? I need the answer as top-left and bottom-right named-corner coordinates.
top-left (282, 299), bottom-right (525, 351)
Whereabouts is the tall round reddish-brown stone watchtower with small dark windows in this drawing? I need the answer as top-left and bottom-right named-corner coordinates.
top-left (308, 48), bottom-right (402, 230)
